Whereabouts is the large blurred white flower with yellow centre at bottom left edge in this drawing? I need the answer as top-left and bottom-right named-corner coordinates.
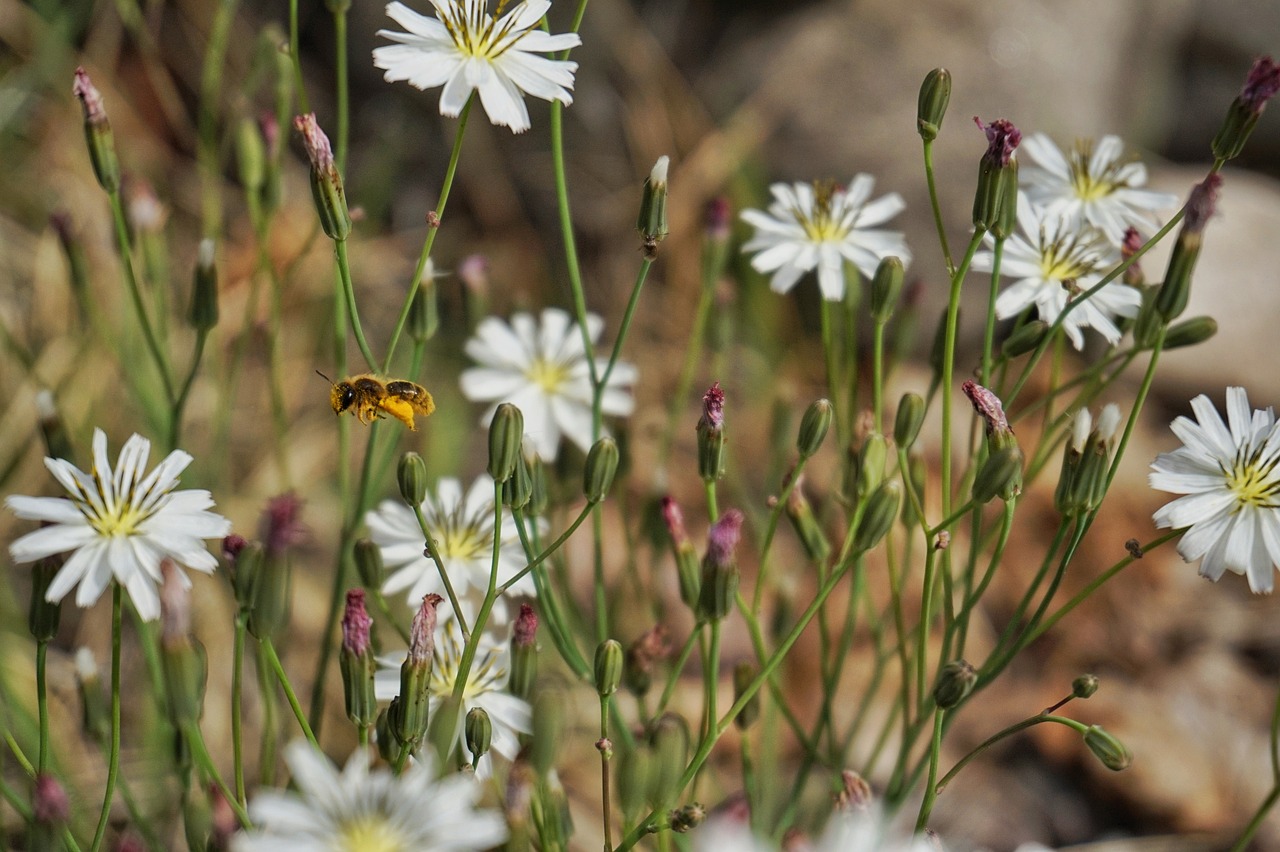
top-left (232, 739), bottom-right (507, 852)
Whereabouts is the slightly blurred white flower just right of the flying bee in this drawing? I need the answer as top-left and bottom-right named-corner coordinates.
top-left (460, 308), bottom-right (636, 462)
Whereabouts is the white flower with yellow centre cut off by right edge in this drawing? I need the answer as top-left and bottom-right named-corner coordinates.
top-left (1149, 388), bottom-right (1280, 595)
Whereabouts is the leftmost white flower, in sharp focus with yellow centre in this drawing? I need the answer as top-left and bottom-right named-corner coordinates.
top-left (5, 429), bottom-right (232, 622)
